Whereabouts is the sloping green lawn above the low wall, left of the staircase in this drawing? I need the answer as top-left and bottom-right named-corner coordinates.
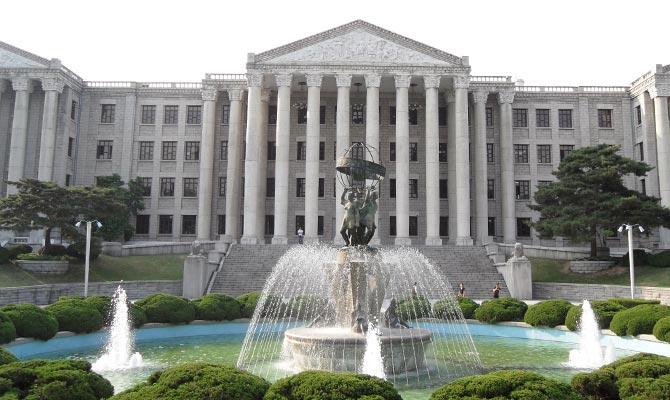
top-left (0, 254), bottom-right (186, 287)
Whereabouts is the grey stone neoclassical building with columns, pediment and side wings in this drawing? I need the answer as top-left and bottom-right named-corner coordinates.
top-left (0, 21), bottom-right (670, 247)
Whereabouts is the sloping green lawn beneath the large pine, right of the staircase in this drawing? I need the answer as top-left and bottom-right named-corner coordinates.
top-left (530, 258), bottom-right (670, 287)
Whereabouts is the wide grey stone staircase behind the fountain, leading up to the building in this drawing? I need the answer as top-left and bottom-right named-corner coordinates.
top-left (210, 244), bottom-right (509, 299)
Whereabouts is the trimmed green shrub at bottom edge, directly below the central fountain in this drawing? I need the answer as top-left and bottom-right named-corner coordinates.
top-left (263, 371), bottom-right (401, 400)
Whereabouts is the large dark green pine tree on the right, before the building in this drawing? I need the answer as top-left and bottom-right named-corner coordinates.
top-left (529, 144), bottom-right (670, 257)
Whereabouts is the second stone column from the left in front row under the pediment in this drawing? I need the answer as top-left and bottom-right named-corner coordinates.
top-left (272, 74), bottom-right (293, 244)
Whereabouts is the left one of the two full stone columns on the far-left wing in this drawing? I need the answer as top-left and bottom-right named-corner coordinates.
top-left (7, 78), bottom-right (33, 194)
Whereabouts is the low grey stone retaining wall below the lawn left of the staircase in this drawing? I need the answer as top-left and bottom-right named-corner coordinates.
top-left (0, 280), bottom-right (182, 306)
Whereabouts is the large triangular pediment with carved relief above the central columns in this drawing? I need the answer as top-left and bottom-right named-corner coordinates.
top-left (254, 20), bottom-right (463, 67)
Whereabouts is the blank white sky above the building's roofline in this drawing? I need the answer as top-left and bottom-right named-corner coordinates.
top-left (0, 0), bottom-right (670, 85)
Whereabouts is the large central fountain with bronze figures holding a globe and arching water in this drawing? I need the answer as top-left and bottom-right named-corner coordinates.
top-left (238, 143), bottom-right (481, 386)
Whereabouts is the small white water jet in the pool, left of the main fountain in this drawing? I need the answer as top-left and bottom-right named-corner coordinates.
top-left (91, 285), bottom-right (143, 372)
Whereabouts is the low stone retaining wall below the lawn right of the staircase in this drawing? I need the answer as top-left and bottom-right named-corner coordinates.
top-left (533, 282), bottom-right (670, 304)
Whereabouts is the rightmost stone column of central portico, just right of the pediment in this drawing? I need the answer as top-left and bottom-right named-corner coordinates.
top-left (498, 91), bottom-right (516, 243)
